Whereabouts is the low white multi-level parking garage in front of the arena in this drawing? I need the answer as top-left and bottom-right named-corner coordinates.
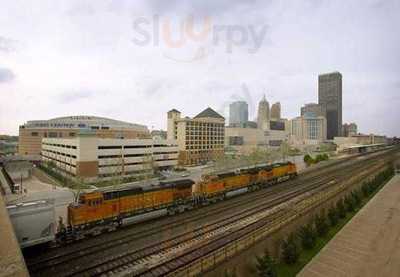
top-left (41, 131), bottom-right (178, 181)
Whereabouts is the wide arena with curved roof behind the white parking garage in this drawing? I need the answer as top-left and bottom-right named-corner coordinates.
top-left (19, 116), bottom-right (150, 155)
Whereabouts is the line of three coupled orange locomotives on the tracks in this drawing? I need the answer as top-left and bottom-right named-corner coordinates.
top-left (58, 162), bottom-right (297, 241)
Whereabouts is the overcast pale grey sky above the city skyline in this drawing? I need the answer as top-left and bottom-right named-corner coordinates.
top-left (0, 0), bottom-right (400, 136)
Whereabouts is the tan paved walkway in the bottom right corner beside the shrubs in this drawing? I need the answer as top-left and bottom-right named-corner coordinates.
top-left (297, 175), bottom-right (400, 277)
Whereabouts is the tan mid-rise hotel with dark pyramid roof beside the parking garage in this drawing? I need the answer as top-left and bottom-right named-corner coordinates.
top-left (167, 108), bottom-right (225, 165)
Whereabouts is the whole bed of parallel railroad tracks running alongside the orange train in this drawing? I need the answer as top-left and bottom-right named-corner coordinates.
top-left (25, 146), bottom-right (397, 276)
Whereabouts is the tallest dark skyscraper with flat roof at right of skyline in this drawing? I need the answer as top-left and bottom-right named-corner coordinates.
top-left (318, 72), bottom-right (342, 139)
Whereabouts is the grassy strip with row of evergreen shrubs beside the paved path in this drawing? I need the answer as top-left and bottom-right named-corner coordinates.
top-left (276, 167), bottom-right (393, 277)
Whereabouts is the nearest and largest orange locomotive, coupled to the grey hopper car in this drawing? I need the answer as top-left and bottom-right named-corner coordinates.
top-left (66, 179), bottom-right (194, 238)
